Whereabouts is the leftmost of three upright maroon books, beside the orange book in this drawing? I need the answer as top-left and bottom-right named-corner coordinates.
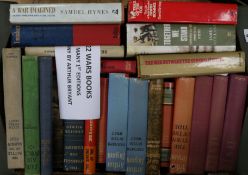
top-left (187, 76), bottom-right (213, 174)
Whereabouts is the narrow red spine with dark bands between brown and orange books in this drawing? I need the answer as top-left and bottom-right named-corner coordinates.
top-left (160, 81), bottom-right (174, 167)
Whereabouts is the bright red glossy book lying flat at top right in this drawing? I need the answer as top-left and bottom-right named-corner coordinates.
top-left (128, 0), bottom-right (237, 24)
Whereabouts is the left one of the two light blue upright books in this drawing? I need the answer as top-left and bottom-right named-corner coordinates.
top-left (106, 73), bottom-right (129, 172)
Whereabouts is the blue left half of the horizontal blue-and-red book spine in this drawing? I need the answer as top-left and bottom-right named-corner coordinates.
top-left (11, 25), bottom-right (73, 47)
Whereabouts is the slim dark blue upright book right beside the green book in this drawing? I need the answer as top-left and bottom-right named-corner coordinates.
top-left (39, 57), bottom-right (53, 175)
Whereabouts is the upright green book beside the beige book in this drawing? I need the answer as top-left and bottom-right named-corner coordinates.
top-left (22, 56), bottom-right (40, 175)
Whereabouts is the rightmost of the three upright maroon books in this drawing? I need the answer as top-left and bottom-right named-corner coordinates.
top-left (218, 74), bottom-right (248, 171)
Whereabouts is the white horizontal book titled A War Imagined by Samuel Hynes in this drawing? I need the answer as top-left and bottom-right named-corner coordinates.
top-left (10, 2), bottom-right (124, 24)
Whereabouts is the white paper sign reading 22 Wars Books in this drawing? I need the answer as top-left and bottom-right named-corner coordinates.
top-left (55, 46), bottom-right (100, 120)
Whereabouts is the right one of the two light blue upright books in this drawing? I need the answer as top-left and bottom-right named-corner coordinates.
top-left (126, 78), bottom-right (148, 175)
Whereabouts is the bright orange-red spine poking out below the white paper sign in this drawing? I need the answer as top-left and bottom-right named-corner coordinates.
top-left (84, 120), bottom-right (98, 174)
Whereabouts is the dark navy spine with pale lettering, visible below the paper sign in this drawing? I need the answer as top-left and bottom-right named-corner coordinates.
top-left (64, 120), bottom-right (84, 172)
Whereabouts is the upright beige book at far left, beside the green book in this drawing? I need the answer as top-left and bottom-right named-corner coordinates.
top-left (2, 48), bottom-right (24, 169)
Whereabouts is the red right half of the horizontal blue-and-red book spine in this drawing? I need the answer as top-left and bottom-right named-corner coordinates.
top-left (73, 24), bottom-right (120, 45)
